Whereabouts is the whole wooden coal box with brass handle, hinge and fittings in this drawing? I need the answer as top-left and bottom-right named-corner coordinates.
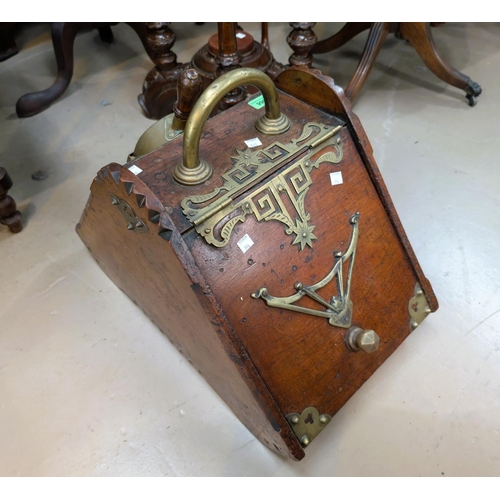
top-left (77, 66), bottom-right (438, 460)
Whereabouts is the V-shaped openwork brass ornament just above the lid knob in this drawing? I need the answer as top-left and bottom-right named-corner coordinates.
top-left (251, 213), bottom-right (359, 328)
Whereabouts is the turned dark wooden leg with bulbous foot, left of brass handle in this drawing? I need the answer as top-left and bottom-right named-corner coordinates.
top-left (137, 23), bottom-right (188, 120)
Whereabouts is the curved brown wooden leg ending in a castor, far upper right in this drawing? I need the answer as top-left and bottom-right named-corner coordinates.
top-left (399, 23), bottom-right (481, 106)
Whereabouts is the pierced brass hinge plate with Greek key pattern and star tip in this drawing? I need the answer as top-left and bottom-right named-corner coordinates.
top-left (181, 123), bottom-right (343, 250)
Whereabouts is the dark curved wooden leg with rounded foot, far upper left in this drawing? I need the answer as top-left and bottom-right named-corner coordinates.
top-left (16, 23), bottom-right (91, 118)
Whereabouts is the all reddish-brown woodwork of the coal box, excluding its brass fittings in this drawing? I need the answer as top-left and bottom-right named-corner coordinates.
top-left (78, 68), bottom-right (437, 460)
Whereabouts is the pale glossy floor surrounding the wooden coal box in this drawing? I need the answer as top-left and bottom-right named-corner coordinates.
top-left (0, 22), bottom-right (500, 476)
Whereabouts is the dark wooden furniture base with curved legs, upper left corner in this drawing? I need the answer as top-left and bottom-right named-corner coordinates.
top-left (16, 23), bottom-right (156, 118)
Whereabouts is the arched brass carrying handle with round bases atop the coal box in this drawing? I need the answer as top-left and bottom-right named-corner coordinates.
top-left (174, 68), bottom-right (291, 185)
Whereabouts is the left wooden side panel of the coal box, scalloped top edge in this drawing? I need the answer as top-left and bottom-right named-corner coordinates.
top-left (77, 164), bottom-right (304, 460)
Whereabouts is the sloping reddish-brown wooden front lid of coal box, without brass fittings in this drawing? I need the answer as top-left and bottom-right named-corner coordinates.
top-left (186, 128), bottom-right (428, 415)
